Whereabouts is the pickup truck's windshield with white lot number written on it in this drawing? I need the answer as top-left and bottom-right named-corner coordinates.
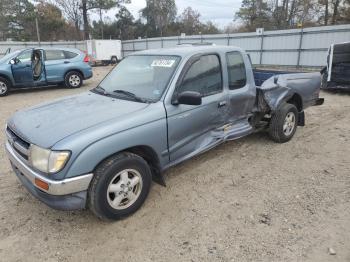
top-left (94, 55), bottom-right (180, 102)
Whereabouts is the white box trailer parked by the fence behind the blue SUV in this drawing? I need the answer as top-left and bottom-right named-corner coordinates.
top-left (86, 40), bottom-right (122, 64)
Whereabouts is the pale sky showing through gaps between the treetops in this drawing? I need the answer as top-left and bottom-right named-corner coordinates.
top-left (100, 0), bottom-right (241, 28)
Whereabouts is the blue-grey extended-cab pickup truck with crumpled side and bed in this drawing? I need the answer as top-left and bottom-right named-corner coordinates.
top-left (6, 46), bottom-right (323, 220)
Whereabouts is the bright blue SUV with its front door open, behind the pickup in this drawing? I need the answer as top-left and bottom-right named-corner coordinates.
top-left (0, 48), bottom-right (92, 96)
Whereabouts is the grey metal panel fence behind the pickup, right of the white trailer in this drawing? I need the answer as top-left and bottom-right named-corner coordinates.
top-left (123, 25), bottom-right (350, 67)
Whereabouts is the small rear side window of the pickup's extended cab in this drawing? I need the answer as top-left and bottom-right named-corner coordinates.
top-left (226, 52), bottom-right (247, 90)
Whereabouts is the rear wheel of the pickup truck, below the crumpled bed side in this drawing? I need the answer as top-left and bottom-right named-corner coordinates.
top-left (269, 103), bottom-right (298, 143)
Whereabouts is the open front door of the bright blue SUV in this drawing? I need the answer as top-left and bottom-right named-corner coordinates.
top-left (11, 49), bottom-right (34, 87)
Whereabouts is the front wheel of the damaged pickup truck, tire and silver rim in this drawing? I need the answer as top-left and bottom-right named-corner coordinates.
top-left (88, 152), bottom-right (152, 220)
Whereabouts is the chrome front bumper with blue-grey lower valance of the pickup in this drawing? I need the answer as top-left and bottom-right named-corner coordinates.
top-left (6, 142), bottom-right (93, 210)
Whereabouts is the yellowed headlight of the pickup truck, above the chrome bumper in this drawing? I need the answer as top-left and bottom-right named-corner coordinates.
top-left (29, 145), bottom-right (70, 173)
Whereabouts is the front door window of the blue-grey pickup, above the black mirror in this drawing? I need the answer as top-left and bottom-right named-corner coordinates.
top-left (176, 55), bottom-right (223, 96)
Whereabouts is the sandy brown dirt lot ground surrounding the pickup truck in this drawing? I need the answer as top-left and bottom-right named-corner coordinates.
top-left (0, 67), bottom-right (350, 262)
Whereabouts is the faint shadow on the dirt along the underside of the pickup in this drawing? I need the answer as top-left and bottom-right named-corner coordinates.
top-left (11, 132), bottom-right (275, 223)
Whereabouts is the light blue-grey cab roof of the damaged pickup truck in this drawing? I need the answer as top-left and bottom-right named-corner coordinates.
top-left (132, 45), bottom-right (244, 57)
